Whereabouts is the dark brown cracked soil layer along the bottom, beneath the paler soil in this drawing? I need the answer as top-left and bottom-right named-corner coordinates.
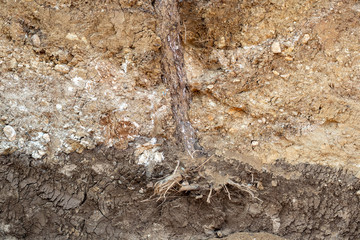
top-left (0, 145), bottom-right (360, 239)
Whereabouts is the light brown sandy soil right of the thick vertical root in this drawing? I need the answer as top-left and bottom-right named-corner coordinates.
top-left (187, 1), bottom-right (360, 174)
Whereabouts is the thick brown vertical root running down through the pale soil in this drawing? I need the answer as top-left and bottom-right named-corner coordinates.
top-left (155, 0), bottom-right (196, 154)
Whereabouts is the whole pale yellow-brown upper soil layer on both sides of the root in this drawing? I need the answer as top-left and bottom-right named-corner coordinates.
top-left (0, 0), bottom-right (360, 176)
